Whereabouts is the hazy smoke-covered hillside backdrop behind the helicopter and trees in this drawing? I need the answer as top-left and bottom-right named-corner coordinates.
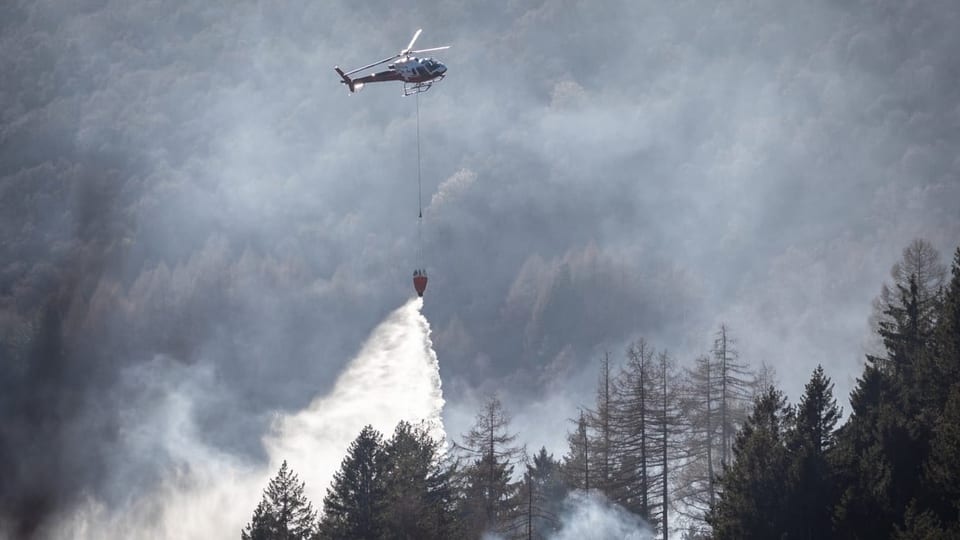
top-left (0, 0), bottom-right (960, 532)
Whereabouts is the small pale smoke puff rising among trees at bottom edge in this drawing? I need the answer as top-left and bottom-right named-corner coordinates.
top-left (552, 491), bottom-right (654, 540)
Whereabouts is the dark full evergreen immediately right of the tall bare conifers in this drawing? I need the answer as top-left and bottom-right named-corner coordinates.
top-left (707, 387), bottom-right (792, 540)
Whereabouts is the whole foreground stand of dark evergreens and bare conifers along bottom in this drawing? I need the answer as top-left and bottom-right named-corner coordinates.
top-left (242, 240), bottom-right (960, 540)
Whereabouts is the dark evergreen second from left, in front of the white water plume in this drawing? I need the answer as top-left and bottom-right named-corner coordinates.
top-left (319, 425), bottom-right (386, 539)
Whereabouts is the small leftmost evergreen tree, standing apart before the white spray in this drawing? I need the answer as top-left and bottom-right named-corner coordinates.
top-left (240, 460), bottom-right (317, 540)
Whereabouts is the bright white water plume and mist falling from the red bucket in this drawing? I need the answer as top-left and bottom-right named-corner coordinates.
top-left (43, 298), bottom-right (445, 539)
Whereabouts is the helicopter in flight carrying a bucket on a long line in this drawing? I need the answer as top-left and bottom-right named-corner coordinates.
top-left (333, 28), bottom-right (450, 96)
